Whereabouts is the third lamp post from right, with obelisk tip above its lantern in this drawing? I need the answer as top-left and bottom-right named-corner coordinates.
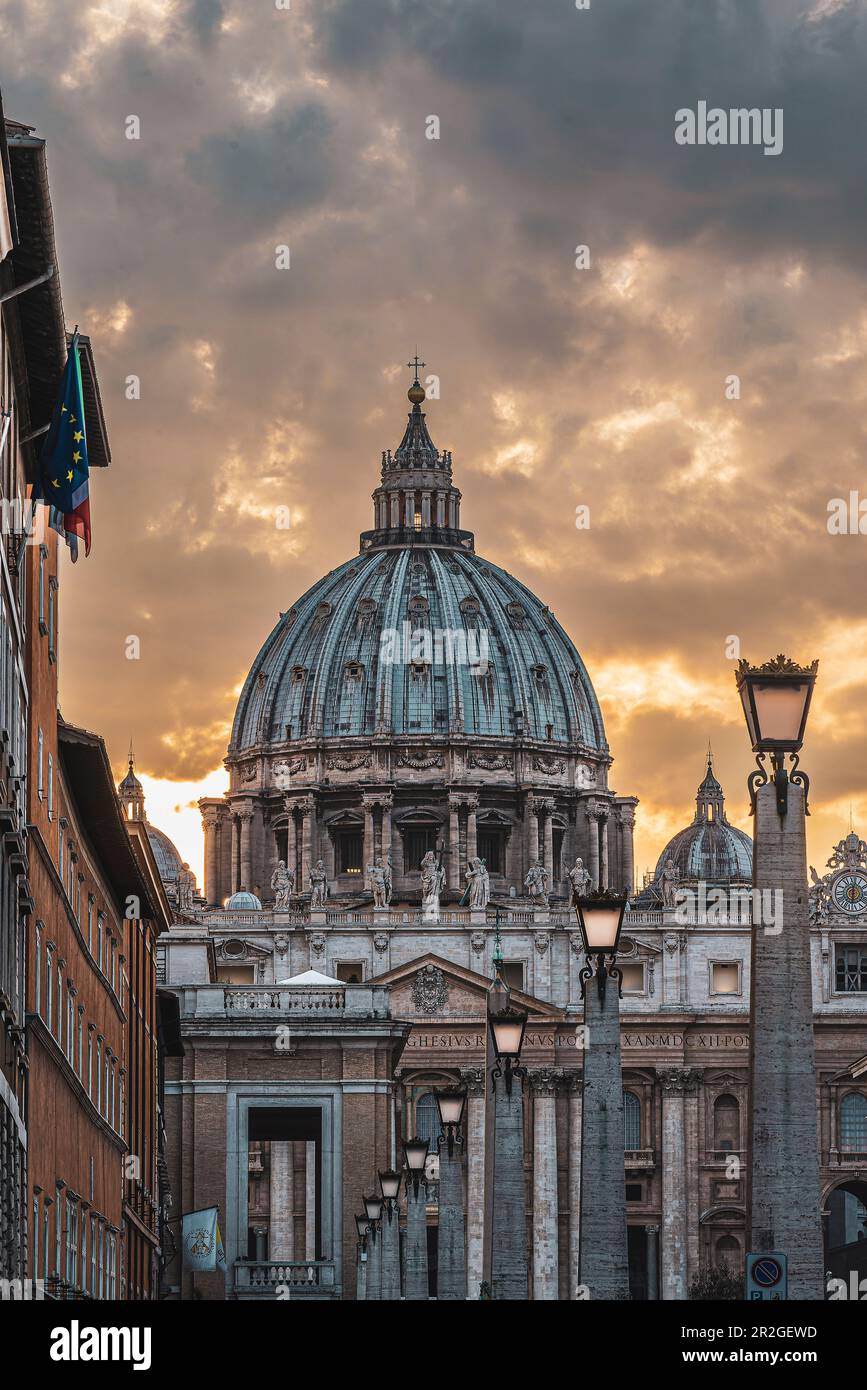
top-left (488, 967), bottom-right (529, 1300)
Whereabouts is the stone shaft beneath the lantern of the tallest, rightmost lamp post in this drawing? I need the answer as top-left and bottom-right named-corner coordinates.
top-left (748, 783), bottom-right (824, 1300)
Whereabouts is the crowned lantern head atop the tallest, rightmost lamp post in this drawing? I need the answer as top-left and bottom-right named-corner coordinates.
top-left (735, 655), bottom-right (818, 816)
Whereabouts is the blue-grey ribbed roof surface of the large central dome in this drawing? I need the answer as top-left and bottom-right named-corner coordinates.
top-left (229, 545), bottom-right (607, 753)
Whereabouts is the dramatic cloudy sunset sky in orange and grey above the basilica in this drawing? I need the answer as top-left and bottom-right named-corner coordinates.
top-left (0, 0), bottom-right (867, 872)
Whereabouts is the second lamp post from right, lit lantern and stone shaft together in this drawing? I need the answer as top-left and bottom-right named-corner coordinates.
top-left (570, 892), bottom-right (629, 1300)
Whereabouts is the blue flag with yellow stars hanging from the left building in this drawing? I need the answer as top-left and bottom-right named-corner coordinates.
top-left (33, 329), bottom-right (90, 560)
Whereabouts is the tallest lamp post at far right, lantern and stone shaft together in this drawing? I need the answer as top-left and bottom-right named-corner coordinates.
top-left (736, 656), bottom-right (824, 1300)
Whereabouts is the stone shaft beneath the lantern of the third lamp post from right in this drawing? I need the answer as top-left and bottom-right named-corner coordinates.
top-left (490, 1077), bottom-right (528, 1300)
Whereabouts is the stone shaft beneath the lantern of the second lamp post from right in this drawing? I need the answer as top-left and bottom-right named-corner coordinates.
top-left (581, 961), bottom-right (629, 1300)
